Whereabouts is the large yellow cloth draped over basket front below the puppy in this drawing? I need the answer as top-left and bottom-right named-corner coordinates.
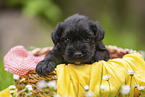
top-left (57, 53), bottom-right (145, 97)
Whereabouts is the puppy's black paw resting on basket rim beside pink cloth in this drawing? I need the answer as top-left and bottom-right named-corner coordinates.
top-left (36, 60), bottom-right (56, 76)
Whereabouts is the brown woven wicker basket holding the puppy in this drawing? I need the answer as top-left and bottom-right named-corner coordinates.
top-left (15, 45), bottom-right (136, 97)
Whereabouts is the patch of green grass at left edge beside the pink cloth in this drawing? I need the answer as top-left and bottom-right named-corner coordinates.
top-left (0, 56), bottom-right (14, 91)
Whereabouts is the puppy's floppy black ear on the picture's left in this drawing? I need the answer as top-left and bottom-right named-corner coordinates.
top-left (51, 23), bottom-right (63, 45)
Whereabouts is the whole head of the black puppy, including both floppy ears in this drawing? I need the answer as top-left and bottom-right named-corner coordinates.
top-left (52, 15), bottom-right (104, 64)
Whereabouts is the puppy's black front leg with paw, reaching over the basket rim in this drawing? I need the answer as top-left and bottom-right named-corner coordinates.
top-left (36, 47), bottom-right (63, 75)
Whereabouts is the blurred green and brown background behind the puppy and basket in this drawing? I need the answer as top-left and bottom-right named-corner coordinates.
top-left (0, 0), bottom-right (145, 90)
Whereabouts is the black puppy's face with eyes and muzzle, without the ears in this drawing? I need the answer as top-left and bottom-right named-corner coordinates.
top-left (60, 24), bottom-right (95, 63)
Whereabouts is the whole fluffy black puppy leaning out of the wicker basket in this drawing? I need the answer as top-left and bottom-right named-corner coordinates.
top-left (36, 14), bottom-right (110, 75)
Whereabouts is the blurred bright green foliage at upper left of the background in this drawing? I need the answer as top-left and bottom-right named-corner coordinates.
top-left (5, 0), bottom-right (62, 25)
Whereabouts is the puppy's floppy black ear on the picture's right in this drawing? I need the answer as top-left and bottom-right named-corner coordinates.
top-left (90, 21), bottom-right (105, 42)
